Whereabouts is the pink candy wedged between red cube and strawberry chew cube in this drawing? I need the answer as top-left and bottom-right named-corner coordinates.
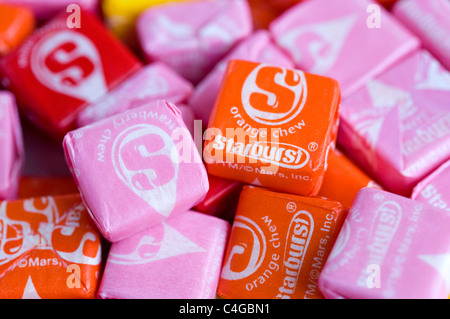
top-left (77, 63), bottom-right (193, 127)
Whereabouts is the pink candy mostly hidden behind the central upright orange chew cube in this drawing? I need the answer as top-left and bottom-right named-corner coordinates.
top-left (189, 30), bottom-right (293, 126)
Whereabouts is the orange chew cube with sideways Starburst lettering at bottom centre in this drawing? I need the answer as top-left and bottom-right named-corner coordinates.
top-left (218, 186), bottom-right (348, 299)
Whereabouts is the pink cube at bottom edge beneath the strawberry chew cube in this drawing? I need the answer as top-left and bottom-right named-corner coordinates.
top-left (98, 211), bottom-right (230, 299)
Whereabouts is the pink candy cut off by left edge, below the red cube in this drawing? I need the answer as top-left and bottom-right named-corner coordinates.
top-left (0, 91), bottom-right (24, 201)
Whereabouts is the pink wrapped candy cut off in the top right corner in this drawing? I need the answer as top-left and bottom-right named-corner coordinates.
top-left (392, 0), bottom-right (450, 70)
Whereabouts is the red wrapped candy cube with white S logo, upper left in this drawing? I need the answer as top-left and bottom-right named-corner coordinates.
top-left (0, 11), bottom-right (141, 137)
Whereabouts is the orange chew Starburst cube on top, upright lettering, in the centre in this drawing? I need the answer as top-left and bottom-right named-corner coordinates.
top-left (203, 60), bottom-right (340, 195)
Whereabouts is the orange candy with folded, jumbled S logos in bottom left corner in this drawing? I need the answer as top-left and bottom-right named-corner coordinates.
top-left (0, 195), bottom-right (103, 299)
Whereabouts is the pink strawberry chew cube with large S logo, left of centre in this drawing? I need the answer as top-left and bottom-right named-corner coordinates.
top-left (64, 101), bottom-right (208, 242)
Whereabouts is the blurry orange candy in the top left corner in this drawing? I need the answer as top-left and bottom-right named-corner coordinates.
top-left (0, 4), bottom-right (35, 56)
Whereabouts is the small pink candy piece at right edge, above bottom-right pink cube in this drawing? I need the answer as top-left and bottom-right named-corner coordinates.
top-left (411, 161), bottom-right (450, 212)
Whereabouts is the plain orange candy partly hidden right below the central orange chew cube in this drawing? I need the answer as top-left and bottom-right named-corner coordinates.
top-left (319, 149), bottom-right (381, 208)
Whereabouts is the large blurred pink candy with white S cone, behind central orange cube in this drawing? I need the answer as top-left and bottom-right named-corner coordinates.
top-left (270, 0), bottom-right (420, 97)
